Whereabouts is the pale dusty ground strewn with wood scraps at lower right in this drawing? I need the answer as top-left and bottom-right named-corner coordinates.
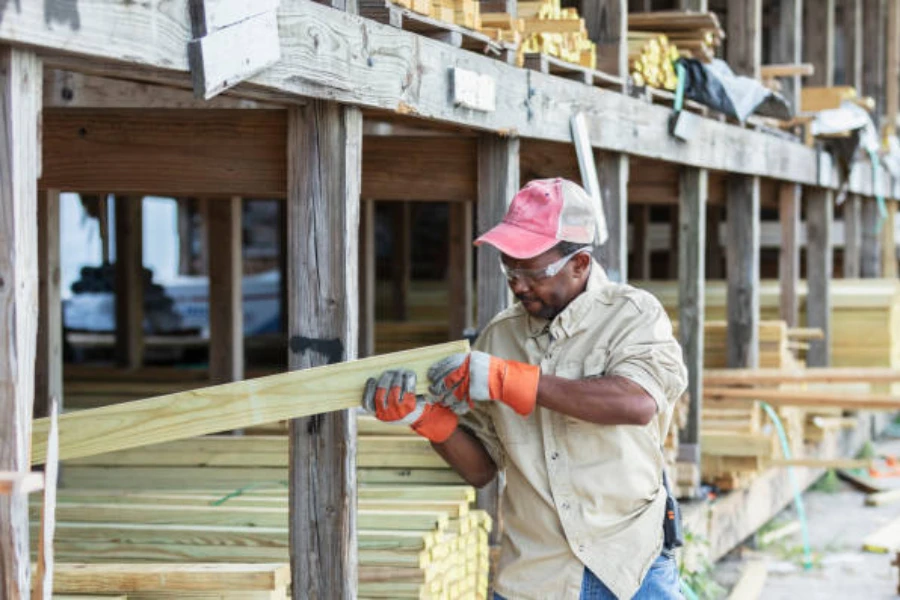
top-left (712, 438), bottom-right (900, 600)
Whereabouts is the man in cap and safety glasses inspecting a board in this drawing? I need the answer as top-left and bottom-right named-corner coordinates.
top-left (364, 179), bottom-right (687, 600)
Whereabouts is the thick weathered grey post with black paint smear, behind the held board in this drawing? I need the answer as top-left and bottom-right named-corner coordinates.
top-left (287, 100), bottom-right (362, 600)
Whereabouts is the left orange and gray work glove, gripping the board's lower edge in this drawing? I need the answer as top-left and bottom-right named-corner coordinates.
top-left (363, 369), bottom-right (459, 443)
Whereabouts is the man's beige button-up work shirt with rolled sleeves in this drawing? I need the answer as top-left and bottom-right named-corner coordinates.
top-left (462, 262), bottom-right (687, 600)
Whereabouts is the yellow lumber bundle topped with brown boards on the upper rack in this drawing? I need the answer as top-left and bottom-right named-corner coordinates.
top-left (628, 11), bottom-right (725, 90)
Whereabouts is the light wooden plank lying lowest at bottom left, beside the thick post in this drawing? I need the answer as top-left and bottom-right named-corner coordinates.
top-left (56, 563), bottom-right (291, 594)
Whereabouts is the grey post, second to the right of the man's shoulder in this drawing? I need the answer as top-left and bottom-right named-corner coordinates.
top-left (726, 176), bottom-right (760, 368)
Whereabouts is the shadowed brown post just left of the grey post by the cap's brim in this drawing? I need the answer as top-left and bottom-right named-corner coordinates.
top-left (447, 202), bottom-right (473, 340)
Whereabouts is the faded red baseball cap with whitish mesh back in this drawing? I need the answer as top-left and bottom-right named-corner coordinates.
top-left (475, 177), bottom-right (597, 259)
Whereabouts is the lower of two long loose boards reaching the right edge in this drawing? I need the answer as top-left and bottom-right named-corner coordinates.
top-left (703, 387), bottom-right (900, 410)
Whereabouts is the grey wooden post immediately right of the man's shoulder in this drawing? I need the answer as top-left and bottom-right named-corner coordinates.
top-left (678, 167), bottom-right (709, 464)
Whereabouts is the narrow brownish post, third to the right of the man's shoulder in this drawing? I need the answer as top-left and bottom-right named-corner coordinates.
top-left (778, 183), bottom-right (802, 327)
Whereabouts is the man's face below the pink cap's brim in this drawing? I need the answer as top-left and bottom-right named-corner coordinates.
top-left (501, 248), bottom-right (591, 319)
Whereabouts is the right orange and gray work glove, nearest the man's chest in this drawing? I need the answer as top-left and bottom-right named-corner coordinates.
top-left (428, 351), bottom-right (541, 416)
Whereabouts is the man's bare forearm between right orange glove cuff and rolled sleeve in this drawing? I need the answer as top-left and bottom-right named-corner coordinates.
top-left (537, 375), bottom-right (656, 425)
